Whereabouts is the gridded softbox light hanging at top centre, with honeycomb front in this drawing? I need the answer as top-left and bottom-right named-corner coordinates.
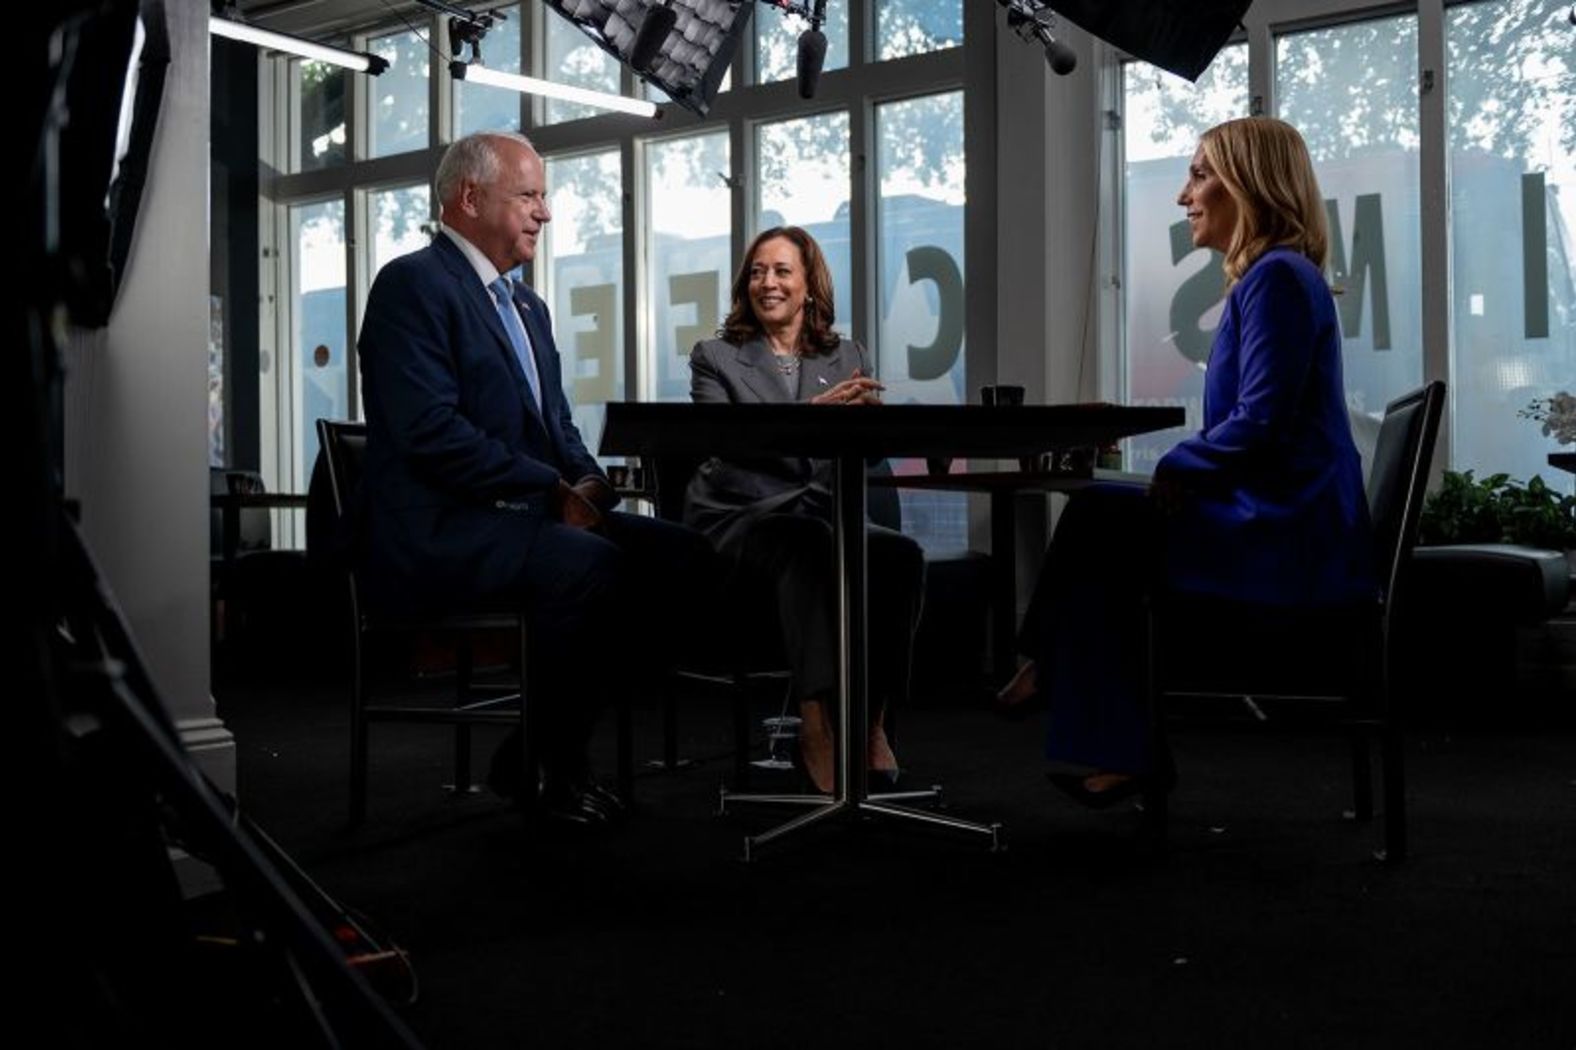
top-left (547, 0), bottom-right (753, 117)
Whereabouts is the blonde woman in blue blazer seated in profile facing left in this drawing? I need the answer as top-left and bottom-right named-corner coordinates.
top-left (999, 117), bottom-right (1376, 806)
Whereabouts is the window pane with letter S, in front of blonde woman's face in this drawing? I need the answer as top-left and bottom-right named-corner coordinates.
top-left (1122, 44), bottom-right (1248, 473)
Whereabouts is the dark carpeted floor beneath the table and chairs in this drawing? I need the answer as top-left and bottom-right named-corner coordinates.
top-left (216, 646), bottom-right (1576, 1050)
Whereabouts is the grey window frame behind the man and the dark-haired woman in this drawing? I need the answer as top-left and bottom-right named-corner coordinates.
top-left (260, 0), bottom-right (970, 510)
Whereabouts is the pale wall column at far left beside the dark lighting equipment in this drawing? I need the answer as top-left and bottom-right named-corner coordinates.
top-left (65, 0), bottom-right (235, 790)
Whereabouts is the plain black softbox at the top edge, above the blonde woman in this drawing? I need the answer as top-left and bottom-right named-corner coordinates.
top-left (1048, 0), bottom-right (1253, 80)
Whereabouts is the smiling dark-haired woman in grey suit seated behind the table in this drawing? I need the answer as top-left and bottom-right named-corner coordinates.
top-left (684, 225), bottom-right (925, 791)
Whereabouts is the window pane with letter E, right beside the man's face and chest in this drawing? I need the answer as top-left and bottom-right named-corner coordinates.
top-left (537, 150), bottom-right (624, 449)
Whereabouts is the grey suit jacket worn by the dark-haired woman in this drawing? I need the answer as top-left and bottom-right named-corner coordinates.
top-left (684, 332), bottom-right (873, 550)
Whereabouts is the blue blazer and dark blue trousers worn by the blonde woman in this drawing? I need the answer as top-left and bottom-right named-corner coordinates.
top-left (1020, 242), bottom-right (1376, 773)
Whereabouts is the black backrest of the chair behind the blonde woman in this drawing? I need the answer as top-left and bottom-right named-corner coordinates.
top-left (1368, 380), bottom-right (1445, 607)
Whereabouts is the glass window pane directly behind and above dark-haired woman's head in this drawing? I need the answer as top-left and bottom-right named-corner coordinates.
top-left (755, 114), bottom-right (854, 336)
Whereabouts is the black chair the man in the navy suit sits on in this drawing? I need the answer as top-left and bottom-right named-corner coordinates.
top-left (317, 419), bottom-right (537, 825)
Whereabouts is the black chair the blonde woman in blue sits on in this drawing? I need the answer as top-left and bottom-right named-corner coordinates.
top-left (1144, 382), bottom-right (1445, 861)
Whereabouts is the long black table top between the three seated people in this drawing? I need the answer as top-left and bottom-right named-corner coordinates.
top-left (600, 402), bottom-right (1185, 459)
